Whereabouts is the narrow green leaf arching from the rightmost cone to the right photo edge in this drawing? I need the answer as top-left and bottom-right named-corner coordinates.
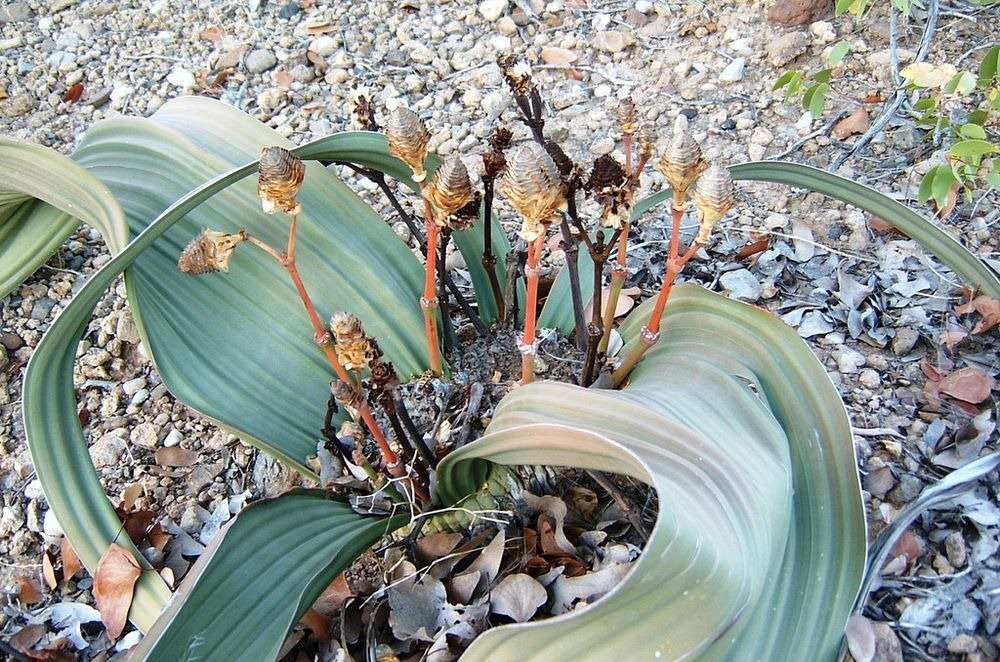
top-left (729, 161), bottom-right (1000, 298)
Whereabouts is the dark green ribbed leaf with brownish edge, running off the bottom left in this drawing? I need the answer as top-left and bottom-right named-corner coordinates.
top-left (133, 490), bottom-right (406, 662)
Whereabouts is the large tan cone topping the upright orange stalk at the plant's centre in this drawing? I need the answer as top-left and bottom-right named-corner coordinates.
top-left (500, 143), bottom-right (566, 241)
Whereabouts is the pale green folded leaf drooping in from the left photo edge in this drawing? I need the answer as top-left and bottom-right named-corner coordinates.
top-left (0, 137), bottom-right (125, 297)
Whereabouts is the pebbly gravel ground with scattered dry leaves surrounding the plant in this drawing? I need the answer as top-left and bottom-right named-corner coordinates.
top-left (0, 0), bottom-right (1000, 660)
